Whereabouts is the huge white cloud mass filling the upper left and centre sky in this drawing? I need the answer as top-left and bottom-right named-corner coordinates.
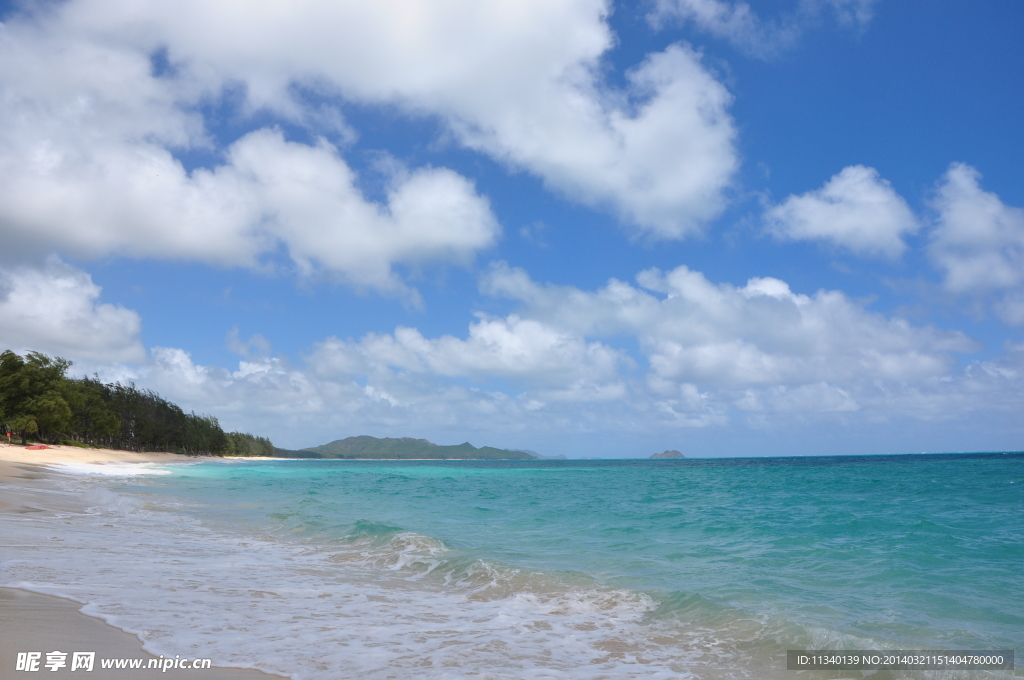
top-left (0, 0), bottom-right (737, 248)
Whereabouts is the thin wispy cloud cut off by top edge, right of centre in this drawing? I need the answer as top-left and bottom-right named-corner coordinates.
top-left (648, 0), bottom-right (874, 58)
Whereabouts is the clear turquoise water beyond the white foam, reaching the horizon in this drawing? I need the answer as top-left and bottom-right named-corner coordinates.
top-left (161, 455), bottom-right (1024, 648)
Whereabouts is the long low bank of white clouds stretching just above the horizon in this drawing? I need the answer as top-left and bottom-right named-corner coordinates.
top-left (75, 264), bottom-right (1024, 455)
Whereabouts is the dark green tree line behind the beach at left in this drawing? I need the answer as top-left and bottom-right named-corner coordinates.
top-left (0, 350), bottom-right (274, 456)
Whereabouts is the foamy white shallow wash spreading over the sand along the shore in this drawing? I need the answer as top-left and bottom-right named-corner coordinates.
top-left (0, 466), bottom-right (737, 680)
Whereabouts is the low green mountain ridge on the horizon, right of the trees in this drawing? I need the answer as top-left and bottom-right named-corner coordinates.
top-left (275, 435), bottom-right (539, 461)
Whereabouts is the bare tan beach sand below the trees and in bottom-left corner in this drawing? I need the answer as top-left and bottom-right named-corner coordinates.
top-left (0, 442), bottom-right (276, 680)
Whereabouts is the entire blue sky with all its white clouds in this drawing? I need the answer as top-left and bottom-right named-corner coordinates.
top-left (0, 0), bottom-right (1024, 457)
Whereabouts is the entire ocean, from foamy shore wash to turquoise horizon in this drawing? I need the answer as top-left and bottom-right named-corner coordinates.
top-left (0, 454), bottom-right (1024, 680)
